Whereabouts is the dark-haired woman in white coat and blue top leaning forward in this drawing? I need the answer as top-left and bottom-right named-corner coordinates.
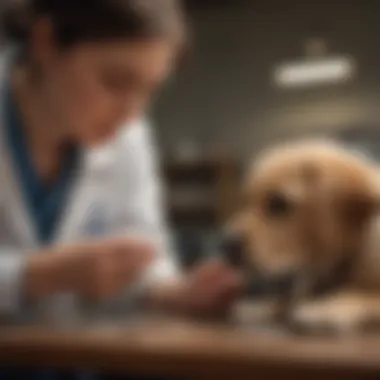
top-left (0, 0), bottom-right (240, 378)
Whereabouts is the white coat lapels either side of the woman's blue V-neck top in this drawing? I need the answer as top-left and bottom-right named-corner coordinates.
top-left (0, 48), bottom-right (116, 249)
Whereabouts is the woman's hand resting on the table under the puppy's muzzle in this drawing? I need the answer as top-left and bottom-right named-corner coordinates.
top-left (151, 260), bottom-right (244, 316)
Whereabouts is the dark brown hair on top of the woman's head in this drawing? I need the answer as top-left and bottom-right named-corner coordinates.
top-left (0, 0), bottom-right (185, 48)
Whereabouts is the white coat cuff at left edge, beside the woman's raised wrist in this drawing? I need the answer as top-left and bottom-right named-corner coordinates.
top-left (0, 248), bottom-right (25, 319)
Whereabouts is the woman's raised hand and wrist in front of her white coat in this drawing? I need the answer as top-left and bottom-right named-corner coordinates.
top-left (25, 238), bottom-right (155, 301)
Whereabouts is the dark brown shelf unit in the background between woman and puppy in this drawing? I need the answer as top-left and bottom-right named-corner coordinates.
top-left (163, 157), bottom-right (239, 226)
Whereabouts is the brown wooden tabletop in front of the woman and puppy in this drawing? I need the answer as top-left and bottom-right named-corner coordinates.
top-left (0, 321), bottom-right (380, 380)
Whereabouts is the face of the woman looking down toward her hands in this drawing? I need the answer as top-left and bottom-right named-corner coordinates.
top-left (35, 39), bottom-right (175, 146)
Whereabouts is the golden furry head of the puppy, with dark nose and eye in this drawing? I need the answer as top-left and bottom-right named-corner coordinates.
top-left (224, 141), bottom-right (380, 296)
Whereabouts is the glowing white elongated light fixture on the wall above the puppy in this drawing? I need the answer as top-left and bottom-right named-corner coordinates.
top-left (274, 57), bottom-right (355, 88)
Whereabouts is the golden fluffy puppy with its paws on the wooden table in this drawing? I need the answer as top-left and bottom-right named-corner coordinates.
top-left (228, 140), bottom-right (380, 332)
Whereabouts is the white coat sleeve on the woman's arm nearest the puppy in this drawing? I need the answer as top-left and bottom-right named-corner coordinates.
top-left (116, 121), bottom-right (180, 287)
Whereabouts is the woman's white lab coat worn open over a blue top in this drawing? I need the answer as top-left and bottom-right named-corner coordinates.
top-left (0, 49), bottom-right (178, 321)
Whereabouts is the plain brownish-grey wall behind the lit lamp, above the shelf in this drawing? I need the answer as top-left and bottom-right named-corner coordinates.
top-left (156, 0), bottom-right (380, 159)
